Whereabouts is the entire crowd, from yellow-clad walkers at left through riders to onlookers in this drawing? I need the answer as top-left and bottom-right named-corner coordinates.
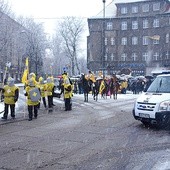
top-left (0, 71), bottom-right (152, 121)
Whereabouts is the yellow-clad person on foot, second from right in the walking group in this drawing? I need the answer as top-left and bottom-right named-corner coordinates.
top-left (47, 77), bottom-right (55, 112)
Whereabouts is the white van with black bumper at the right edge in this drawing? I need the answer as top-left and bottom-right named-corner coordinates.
top-left (133, 72), bottom-right (170, 127)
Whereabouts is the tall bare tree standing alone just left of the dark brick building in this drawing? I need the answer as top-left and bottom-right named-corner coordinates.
top-left (59, 17), bottom-right (85, 75)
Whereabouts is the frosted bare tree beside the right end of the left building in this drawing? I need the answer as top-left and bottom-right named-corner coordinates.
top-left (17, 18), bottom-right (48, 76)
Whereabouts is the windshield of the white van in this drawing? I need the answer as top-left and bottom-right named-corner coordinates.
top-left (147, 76), bottom-right (170, 93)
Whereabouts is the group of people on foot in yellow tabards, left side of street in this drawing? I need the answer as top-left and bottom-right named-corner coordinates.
top-left (0, 72), bottom-right (72, 121)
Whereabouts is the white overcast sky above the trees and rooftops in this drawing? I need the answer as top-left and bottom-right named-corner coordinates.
top-left (7, 0), bottom-right (112, 33)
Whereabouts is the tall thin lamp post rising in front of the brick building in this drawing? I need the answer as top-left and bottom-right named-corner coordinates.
top-left (102, 0), bottom-right (106, 78)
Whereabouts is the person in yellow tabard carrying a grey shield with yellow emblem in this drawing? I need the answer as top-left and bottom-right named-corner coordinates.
top-left (25, 78), bottom-right (41, 121)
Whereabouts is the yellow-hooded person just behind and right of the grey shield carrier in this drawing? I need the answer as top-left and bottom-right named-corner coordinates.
top-left (38, 77), bottom-right (47, 108)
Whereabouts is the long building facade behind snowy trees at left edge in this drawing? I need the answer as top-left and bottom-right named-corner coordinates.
top-left (0, 12), bottom-right (27, 82)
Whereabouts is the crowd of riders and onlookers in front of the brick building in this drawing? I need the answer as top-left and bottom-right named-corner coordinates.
top-left (70, 71), bottom-right (153, 97)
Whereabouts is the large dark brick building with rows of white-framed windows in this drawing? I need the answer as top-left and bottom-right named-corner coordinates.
top-left (87, 0), bottom-right (170, 75)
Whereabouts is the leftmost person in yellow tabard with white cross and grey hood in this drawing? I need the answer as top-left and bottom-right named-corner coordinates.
top-left (0, 77), bottom-right (19, 120)
